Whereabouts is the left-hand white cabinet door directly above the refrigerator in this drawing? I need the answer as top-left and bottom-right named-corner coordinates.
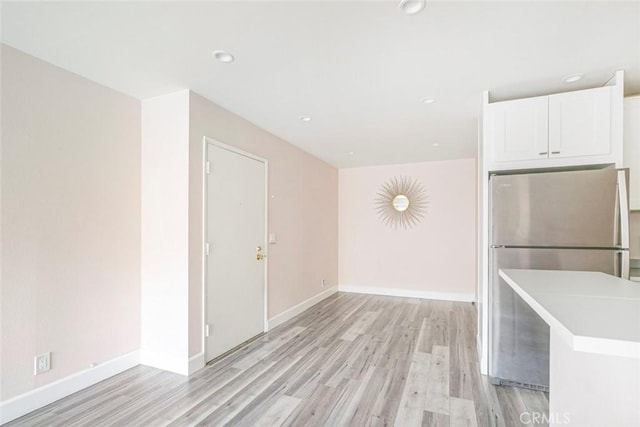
top-left (489, 96), bottom-right (548, 162)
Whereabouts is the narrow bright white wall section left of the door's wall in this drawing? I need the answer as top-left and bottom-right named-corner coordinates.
top-left (140, 90), bottom-right (189, 375)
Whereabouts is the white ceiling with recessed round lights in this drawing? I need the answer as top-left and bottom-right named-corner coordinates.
top-left (1, 1), bottom-right (640, 167)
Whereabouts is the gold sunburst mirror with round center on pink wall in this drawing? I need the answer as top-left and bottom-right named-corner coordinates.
top-left (375, 176), bottom-right (429, 229)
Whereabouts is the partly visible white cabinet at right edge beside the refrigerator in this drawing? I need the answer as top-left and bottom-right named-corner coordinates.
top-left (623, 95), bottom-right (640, 210)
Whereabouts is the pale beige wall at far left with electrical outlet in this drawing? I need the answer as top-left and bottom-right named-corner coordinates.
top-left (0, 46), bottom-right (140, 400)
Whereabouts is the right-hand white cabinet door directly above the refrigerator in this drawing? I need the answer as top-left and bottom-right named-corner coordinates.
top-left (549, 86), bottom-right (612, 158)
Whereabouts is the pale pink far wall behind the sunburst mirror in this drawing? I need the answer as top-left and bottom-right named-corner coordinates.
top-left (339, 159), bottom-right (476, 299)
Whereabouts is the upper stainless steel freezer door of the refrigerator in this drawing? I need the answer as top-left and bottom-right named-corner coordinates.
top-left (490, 169), bottom-right (621, 248)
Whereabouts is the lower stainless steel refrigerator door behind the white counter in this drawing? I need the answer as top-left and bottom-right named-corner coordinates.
top-left (489, 248), bottom-right (620, 388)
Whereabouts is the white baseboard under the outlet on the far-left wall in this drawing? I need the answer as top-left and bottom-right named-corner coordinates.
top-left (0, 350), bottom-right (140, 424)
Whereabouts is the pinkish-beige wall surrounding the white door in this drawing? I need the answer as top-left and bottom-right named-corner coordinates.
top-left (189, 93), bottom-right (338, 356)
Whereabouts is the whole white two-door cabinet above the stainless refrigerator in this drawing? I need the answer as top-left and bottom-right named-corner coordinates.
top-left (479, 71), bottom-right (624, 171)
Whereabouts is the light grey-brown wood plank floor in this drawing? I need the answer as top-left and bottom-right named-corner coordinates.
top-left (9, 293), bottom-right (548, 427)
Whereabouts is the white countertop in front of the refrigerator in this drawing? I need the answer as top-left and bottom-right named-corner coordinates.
top-left (499, 269), bottom-right (640, 359)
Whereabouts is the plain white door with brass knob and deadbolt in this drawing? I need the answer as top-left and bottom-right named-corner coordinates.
top-left (205, 142), bottom-right (266, 361)
